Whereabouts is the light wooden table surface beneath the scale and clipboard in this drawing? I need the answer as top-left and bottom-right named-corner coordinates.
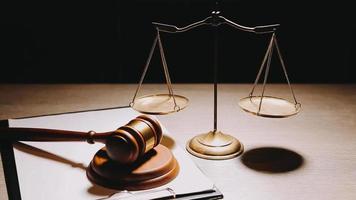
top-left (0, 84), bottom-right (356, 200)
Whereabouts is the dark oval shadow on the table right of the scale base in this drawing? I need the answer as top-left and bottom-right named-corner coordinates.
top-left (241, 147), bottom-right (304, 173)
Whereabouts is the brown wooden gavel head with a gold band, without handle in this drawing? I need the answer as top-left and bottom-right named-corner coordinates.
top-left (105, 115), bottom-right (162, 164)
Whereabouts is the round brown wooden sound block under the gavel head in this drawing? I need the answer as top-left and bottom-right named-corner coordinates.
top-left (87, 145), bottom-right (179, 190)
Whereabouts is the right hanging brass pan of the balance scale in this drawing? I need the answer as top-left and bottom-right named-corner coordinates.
top-left (239, 96), bottom-right (300, 118)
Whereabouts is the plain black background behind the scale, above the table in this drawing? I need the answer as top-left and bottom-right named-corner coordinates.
top-left (0, 0), bottom-right (356, 83)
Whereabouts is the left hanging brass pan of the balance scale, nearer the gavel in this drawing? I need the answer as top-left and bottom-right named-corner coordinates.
top-left (131, 94), bottom-right (189, 115)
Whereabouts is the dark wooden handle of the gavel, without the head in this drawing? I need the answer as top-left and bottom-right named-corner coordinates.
top-left (0, 128), bottom-right (113, 143)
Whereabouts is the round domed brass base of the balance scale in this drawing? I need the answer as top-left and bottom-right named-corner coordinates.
top-left (186, 131), bottom-right (244, 160)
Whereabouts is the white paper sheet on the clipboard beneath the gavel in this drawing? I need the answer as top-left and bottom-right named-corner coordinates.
top-left (9, 108), bottom-right (214, 200)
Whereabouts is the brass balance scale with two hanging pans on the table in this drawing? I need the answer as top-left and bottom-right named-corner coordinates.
top-left (130, 11), bottom-right (301, 160)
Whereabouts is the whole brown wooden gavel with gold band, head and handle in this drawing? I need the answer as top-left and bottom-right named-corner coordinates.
top-left (0, 115), bottom-right (162, 164)
